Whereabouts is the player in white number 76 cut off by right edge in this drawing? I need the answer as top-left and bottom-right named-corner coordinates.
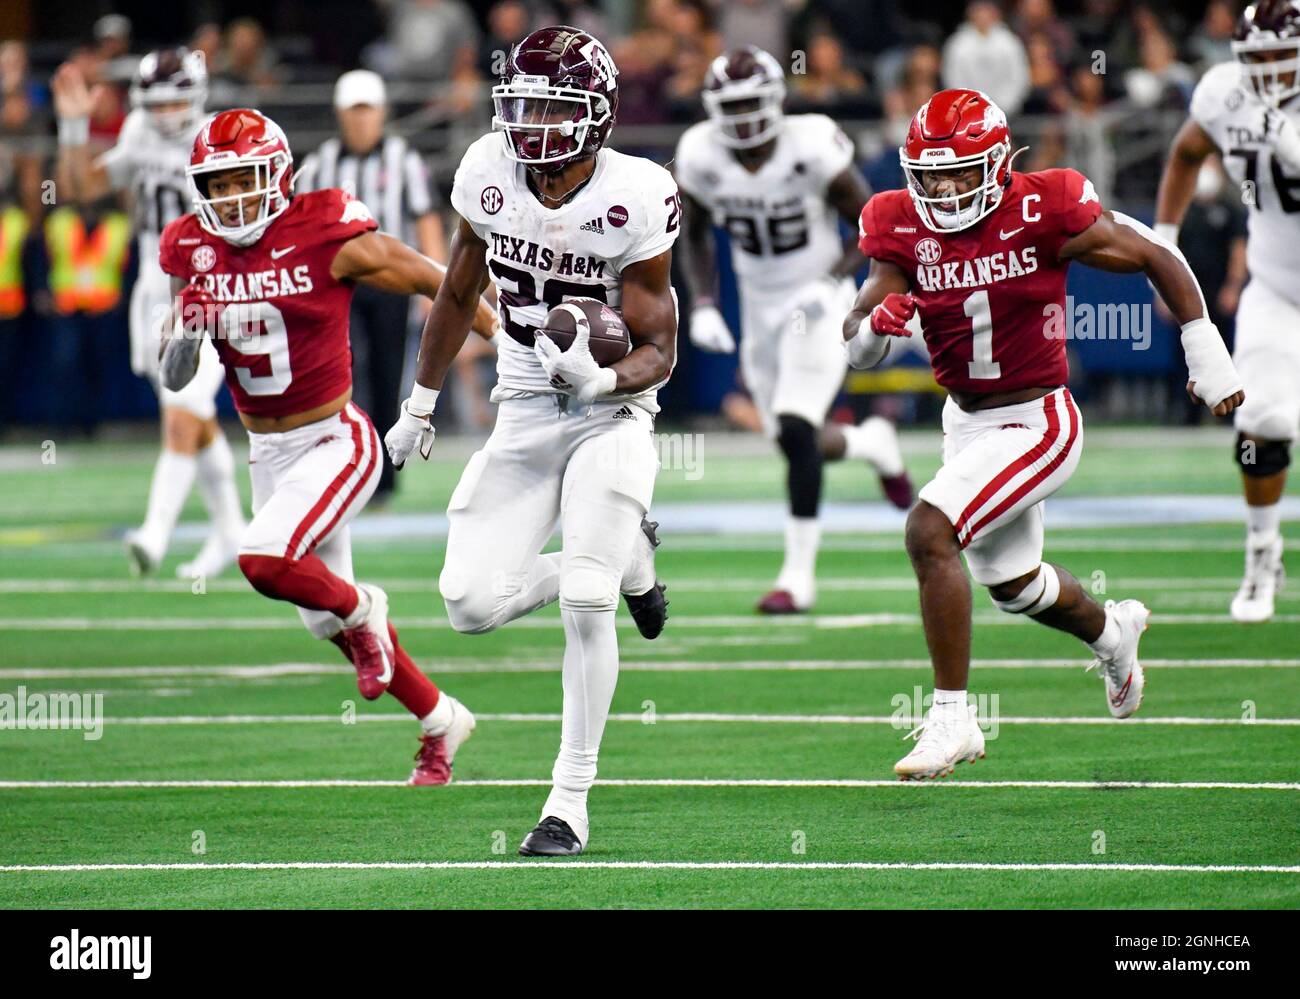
top-left (1156, 0), bottom-right (1300, 622)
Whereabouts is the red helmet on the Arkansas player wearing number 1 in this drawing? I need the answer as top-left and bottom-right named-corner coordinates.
top-left (898, 90), bottom-right (1011, 233)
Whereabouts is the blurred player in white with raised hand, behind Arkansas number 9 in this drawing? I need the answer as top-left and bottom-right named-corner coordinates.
top-left (52, 48), bottom-right (244, 578)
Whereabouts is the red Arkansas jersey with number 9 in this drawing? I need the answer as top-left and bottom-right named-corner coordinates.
top-left (159, 189), bottom-right (378, 416)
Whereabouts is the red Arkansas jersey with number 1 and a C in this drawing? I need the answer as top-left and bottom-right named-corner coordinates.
top-left (858, 170), bottom-right (1101, 394)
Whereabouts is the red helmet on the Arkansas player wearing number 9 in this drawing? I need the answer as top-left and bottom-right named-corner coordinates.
top-left (186, 108), bottom-right (294, 246)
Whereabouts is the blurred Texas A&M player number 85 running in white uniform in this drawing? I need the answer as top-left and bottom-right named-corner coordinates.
top-left (673, 46), bottom-right (911, 614)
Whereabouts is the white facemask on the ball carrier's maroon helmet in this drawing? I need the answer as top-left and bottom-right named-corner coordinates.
top-left (491, 77), bottom-right (611, 173)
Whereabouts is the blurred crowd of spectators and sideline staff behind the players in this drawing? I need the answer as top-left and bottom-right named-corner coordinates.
top-left (0, 0), bottom-right (1240, 432)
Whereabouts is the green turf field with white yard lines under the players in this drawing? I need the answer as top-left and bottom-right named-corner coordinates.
top-left (0, 429), bottom-right (1300, 908)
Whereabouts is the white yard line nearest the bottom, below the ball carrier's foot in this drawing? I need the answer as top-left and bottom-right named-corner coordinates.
top-left (0, 859), bottom-right (1300, 874)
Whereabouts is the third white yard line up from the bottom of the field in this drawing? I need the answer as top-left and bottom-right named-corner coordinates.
top-left (10, 712), bottom-right (1300, 730)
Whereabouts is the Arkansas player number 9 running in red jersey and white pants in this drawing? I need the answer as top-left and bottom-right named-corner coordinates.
top-left (160, 109), bottom-right (494, 784)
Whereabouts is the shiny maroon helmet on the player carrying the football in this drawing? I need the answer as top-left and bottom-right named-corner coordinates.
top-left (491, 25), bottom-right (619, 173)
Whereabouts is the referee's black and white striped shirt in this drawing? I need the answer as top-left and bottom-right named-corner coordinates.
top-left (294, 135), bottom-right (436, 246)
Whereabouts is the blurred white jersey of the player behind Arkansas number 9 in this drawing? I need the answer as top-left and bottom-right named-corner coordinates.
top-left (99, 108), bottom-right (202, 277)
